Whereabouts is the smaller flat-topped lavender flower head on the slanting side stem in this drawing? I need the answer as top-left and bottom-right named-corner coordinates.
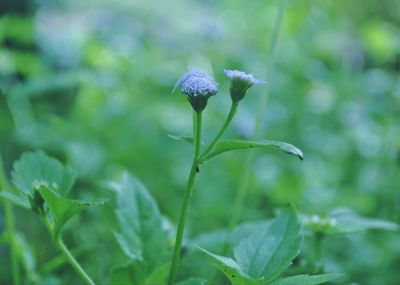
top-left (224, 69), bottom-right (264, 102)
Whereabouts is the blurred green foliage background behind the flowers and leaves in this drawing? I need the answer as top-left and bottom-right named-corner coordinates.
top-left (0, 0), bottom-right (400, 285)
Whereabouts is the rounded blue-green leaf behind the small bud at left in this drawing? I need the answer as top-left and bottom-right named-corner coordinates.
top-left (12, 151), bottom-right (75, 196)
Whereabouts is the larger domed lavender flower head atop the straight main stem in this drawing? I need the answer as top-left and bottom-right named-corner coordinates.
top-left (172, 70), bottom-right (218, 112)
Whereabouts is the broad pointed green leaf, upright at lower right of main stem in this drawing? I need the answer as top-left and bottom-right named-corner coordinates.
top-left (234, 208), bottom-right (301, 283)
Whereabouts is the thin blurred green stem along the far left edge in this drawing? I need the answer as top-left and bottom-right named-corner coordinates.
top-left (0, 154), bottom-right (21, 285)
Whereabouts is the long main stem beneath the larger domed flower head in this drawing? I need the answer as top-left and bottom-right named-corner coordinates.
top-left (168, 111), bottom-right (202, 285)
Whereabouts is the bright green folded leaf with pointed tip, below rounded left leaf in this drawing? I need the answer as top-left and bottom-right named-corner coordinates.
top-left (39, 186), bottom-right (105, 237)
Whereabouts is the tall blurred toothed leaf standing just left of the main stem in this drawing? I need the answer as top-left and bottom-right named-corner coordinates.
top-left (115, 173), bottom-right (169, 275)
